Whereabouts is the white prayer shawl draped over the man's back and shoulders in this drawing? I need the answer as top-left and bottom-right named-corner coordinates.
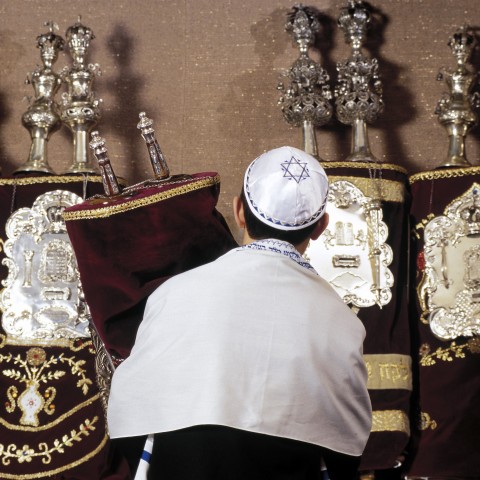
top-left (108, 241), bottom-right (371, 456)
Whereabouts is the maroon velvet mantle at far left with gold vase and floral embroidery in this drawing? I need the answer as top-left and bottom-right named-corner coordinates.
top-left (0, 175), bottom-right (130, 480)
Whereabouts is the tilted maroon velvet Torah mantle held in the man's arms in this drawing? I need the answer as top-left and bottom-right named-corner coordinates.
top-left (66, 173), bottom-right (237, 358)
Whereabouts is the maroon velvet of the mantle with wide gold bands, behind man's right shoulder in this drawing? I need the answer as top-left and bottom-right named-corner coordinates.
top-left (322, 162), bottom-right (411, 472)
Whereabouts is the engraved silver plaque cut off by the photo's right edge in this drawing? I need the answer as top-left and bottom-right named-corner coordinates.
top-left (424, 183), bottom-right (480, 340)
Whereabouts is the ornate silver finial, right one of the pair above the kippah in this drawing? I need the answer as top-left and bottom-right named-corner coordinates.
top-left (334, 0), bottom-right (383, 162)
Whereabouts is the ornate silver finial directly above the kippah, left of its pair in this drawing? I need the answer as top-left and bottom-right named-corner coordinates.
top-left (278, 4), bottom-right (333, 160)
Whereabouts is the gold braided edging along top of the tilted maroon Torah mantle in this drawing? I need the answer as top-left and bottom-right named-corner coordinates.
top-left (63, 175), bottom-right (220, 221)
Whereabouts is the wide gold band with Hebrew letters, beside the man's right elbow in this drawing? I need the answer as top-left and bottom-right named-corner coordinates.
top-left (363, 353), bottom-right (412, 391)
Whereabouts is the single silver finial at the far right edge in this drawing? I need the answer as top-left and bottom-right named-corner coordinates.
top-left (435, 26), bottom-right (479, 168)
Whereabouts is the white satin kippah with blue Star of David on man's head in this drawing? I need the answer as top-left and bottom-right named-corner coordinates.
top-left (244, 147), bottom-right (328, 230)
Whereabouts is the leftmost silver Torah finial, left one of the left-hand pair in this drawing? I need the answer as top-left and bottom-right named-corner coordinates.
top-left (15, 22), bottom-right (65, 174)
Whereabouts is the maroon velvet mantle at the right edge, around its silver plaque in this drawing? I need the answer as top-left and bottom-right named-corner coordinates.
top-left (409, 167), bottom-right (480, 479)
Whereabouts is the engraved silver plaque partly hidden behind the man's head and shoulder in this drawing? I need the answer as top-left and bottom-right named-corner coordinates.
top-left (305, 180), bottom-right (394, 307)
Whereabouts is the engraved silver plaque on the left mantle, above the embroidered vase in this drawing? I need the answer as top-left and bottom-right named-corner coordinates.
top-left (0, 190), bottom-right (90, 341)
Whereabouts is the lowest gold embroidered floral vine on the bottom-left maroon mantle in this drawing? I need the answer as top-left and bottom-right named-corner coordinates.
top-left (0, 416), bottom-right (98, 465)
